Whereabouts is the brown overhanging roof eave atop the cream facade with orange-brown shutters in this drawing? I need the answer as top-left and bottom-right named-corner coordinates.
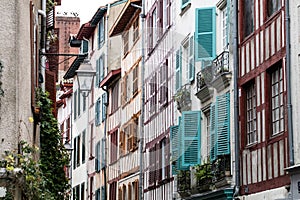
top-left (109, 0), bottom-right (142, 37)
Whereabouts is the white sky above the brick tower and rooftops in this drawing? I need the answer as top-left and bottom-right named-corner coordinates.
top-left (56, 0), bottom-right (114, 24)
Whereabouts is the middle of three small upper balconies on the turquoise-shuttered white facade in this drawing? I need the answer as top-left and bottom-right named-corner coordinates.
top-left (196, 65), bottom-right (213, 103)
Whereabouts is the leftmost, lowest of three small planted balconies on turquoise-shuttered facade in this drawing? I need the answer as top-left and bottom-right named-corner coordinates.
top-left (173, 84), bottom-right (192, 112)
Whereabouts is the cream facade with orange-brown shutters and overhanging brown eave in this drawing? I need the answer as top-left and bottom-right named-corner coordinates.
top-left (107, 0), bottom-right (141, 200)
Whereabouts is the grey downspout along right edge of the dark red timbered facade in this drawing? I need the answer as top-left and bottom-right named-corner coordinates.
top-left (285, 0), bottom-right (294, 166)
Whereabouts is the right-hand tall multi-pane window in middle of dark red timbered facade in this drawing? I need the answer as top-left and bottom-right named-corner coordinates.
top-left (270, 62), bottom-right (284, 136)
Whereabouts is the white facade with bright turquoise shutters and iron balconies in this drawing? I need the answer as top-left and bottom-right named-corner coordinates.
top-left (170, 0), bottom-right (234, 199)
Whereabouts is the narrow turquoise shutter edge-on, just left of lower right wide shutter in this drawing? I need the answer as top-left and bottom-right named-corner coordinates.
top-left (209, 104), bottom-right (217, 161)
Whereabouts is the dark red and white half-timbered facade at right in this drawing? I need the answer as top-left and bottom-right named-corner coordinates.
top-left (238, 0), bottom-right (290, 199)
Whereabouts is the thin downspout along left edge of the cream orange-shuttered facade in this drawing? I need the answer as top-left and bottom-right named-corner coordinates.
top-left (102, 4), bottom-right (110, 199)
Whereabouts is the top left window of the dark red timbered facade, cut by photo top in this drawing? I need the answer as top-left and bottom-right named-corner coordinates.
top-left (243, 0), bottom-right (254, 38)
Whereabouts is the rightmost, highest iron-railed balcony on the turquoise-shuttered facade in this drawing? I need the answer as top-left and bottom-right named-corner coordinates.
top-left (210, 51), bottom-right (232, 92)
